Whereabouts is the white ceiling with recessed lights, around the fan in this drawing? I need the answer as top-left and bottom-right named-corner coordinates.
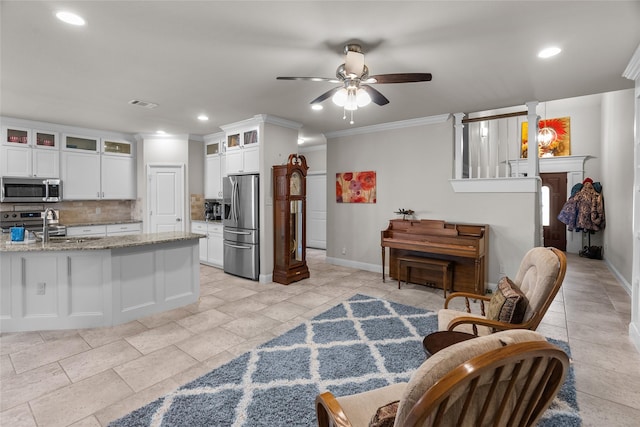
top-left (0, 0), bottom-right (640, 145)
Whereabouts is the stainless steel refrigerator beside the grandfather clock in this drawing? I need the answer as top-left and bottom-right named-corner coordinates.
top-left (222, 175), bottom-right (260, 280)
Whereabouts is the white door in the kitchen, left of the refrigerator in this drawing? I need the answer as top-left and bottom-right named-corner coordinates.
top-left (147, 165), bottom-right (184, 233)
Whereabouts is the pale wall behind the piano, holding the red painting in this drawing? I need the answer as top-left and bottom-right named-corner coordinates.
top-left (327, 120), bottom-right (535, 283)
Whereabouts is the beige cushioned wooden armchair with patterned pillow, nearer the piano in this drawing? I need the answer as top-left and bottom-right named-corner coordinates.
top-left (438, 247), bottom-right (567, 335)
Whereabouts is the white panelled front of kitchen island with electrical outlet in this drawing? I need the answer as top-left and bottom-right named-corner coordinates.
top-left (0, 251), bottom-right (111, 331)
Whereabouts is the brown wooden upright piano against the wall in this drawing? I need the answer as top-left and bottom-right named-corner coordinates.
top-left (380, 219), bottom-right (489, 295)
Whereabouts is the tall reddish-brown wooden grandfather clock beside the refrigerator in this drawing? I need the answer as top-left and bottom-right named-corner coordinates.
top-left (273, 154), bottom-right (309, 285)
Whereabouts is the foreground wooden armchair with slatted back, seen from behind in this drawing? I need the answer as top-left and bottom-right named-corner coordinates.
top-left (316, 330), bottom-right (569, 427)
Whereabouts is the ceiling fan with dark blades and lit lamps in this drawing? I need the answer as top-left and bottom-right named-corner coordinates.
top-left (277, 44), bottom-right (431, 124)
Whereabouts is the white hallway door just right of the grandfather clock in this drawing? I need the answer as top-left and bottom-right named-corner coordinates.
top-left (307, 173), bottom-right (327, 249)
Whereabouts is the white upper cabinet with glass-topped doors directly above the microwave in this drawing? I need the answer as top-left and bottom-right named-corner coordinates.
top-left (0, 126), bottom-right (60, 178)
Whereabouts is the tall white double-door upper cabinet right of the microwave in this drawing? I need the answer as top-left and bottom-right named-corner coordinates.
top-left (61, 135), bottom-right (136, 200)
